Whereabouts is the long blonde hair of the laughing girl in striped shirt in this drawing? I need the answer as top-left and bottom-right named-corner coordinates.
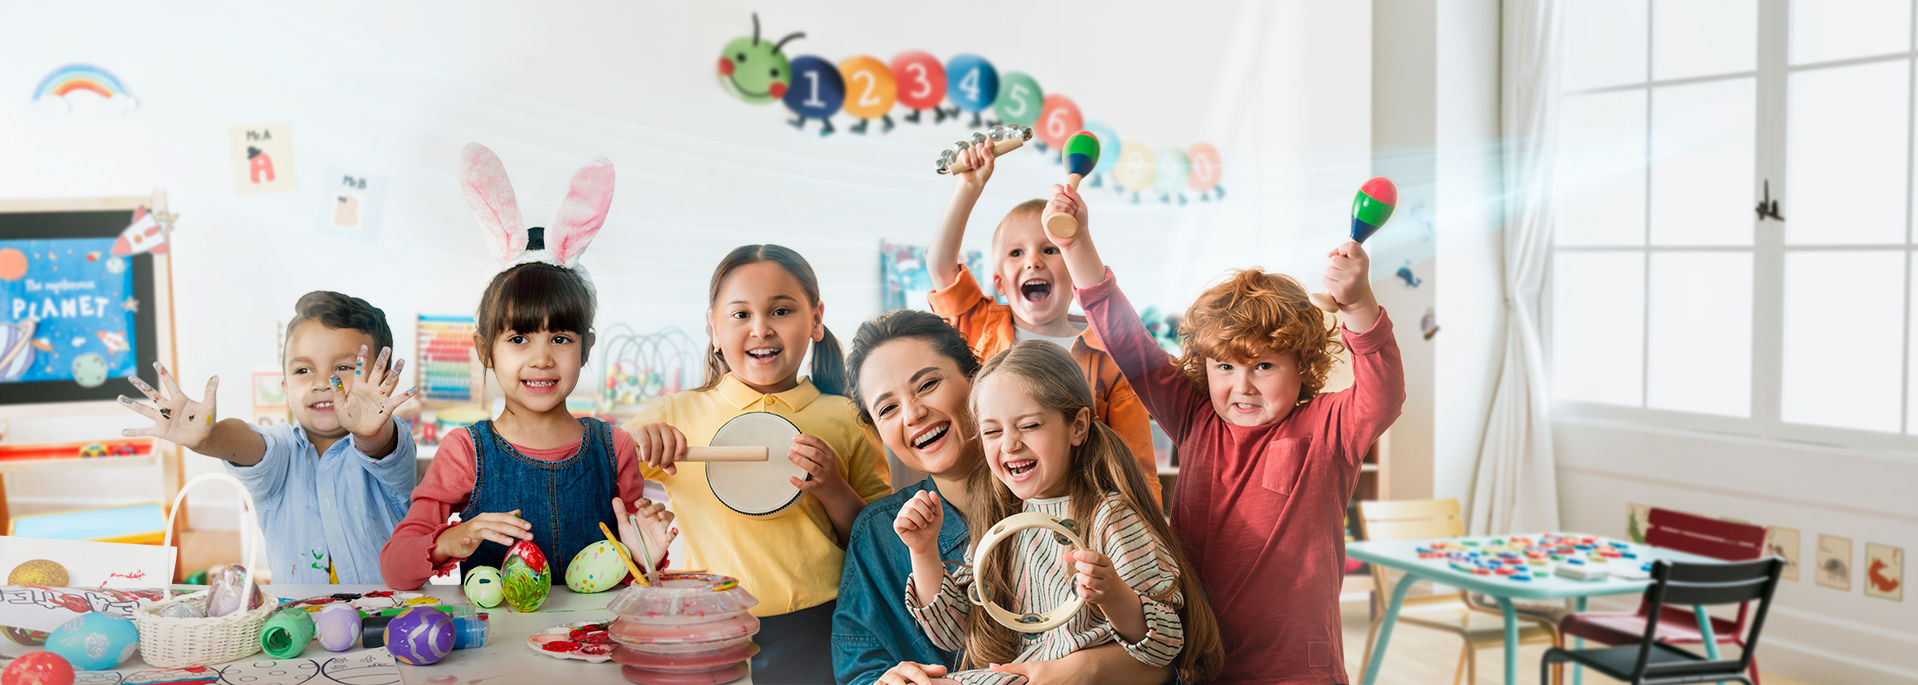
top-left (961, 340), bottom-right (1226, 683)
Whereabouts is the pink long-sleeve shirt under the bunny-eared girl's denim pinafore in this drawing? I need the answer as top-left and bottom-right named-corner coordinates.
top-left (380, 428), bottom-right (646, 589)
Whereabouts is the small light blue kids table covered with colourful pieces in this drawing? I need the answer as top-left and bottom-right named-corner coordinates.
top-left (1345, 533), bottom-right (1719, 685)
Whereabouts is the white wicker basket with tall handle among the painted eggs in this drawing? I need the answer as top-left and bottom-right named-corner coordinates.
top-left (132, 474), bottom-right (280, 668)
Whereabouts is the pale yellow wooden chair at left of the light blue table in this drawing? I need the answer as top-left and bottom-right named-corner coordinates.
top-left (1358, 499), bottom-right (1559, 685)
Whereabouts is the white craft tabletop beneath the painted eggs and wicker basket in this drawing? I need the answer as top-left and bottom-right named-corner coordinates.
top-left (0, 585), bottom-right (752, 685)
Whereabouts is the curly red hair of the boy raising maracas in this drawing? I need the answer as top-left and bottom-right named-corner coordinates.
top-left (1180, 269), bottom-right (1345, 401)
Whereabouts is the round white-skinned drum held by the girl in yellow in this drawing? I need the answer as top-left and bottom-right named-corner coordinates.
top-left (705, 411), bottom-right (809, 518)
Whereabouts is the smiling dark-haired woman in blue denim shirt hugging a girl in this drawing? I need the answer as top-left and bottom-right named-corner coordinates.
top-left (832, 309), bottom-right (1170, 685)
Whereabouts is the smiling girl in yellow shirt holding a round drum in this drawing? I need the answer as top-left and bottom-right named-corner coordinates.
top-left (627, 246), bottom-right (892, 683)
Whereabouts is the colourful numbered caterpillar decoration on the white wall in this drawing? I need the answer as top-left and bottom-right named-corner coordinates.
top-left (719, 13), bottom-right (1226, 205)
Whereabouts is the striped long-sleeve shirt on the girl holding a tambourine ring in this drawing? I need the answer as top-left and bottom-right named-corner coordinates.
top-left (905, 493), bottom-right (1185, 685)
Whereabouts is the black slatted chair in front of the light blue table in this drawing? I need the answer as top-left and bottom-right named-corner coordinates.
top-left (1540, 556), bottom-right (1784, 685)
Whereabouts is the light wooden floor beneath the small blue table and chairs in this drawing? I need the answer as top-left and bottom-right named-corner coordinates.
top-left (1343, 602), bottom-right (1811, 685)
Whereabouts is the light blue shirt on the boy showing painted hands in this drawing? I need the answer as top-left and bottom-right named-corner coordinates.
top-left (224, 418), bottom-right (420, 585)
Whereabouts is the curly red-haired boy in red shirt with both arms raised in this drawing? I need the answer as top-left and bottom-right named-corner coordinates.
top-left (1045, 186), bottom-right (1406, 685)
